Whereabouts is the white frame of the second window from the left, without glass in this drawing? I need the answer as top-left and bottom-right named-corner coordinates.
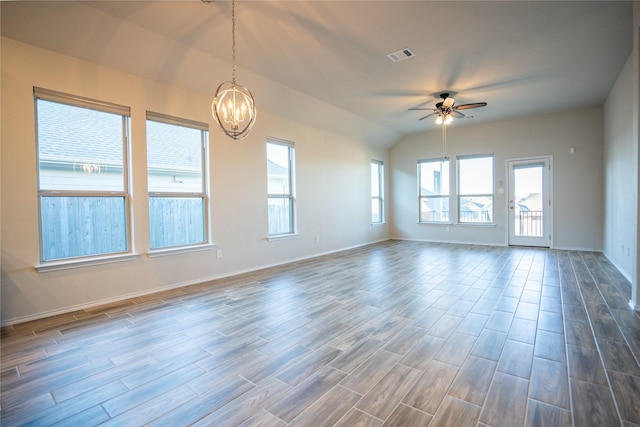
top-left (145, 111), bottom-right (211, 256)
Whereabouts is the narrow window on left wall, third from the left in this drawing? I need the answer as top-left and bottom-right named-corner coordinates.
top-left (267, 139), bottom-right (295, 236)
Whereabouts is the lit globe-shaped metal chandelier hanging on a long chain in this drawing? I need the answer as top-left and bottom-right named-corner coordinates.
top-left (211, 0), bottom-right (256, 140)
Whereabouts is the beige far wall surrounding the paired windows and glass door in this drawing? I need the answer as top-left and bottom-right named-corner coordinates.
top-left (390, 107), bottom-right (603, 251)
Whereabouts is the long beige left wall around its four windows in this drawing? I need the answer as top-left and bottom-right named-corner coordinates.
top-left (0, 39), bottom-right (388, 324)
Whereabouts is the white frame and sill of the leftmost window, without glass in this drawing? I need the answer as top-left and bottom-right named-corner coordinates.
top-left (33, 86), bottom-right (137, 272)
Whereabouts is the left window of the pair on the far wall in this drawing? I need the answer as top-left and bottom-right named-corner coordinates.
top-left (418, 159), bottom-right (450, 222)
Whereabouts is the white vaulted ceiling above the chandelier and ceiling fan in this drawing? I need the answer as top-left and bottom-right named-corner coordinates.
top-left (0, 0), bottom-right (633, 146)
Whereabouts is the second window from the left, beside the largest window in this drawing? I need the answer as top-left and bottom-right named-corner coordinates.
top-left (147, 112), bottom-right (208, 249)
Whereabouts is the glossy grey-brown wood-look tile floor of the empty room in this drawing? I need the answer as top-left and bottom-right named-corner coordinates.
top-left (0, 241), bottom-right (640, 427)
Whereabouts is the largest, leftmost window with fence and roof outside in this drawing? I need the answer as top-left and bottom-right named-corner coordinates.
top-left (34, 88), bottom-right (131, 261)
